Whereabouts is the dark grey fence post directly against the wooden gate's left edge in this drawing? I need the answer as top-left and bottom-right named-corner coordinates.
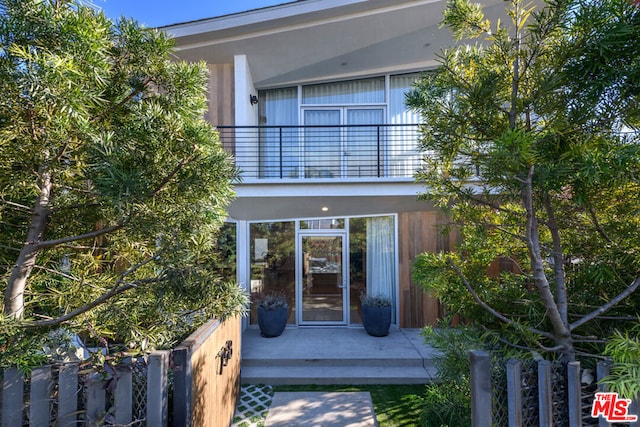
top-left (171, 347), bottom-right (191, 427)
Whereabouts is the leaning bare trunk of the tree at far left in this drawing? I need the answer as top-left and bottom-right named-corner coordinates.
top-left (4, 170), bottom-right (53, 318)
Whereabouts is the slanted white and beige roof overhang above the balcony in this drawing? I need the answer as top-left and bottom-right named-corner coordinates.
top-left (163, 0), bottom-right (504, 88)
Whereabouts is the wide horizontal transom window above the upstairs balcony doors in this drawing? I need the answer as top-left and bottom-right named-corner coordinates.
top-left (302, 77), bottom-right (385, 105)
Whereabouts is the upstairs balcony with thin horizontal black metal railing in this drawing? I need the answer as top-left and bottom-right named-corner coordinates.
top-left (217, 124), bottom-right (421, 182)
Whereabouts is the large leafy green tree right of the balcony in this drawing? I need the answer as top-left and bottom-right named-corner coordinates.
top-left (407, 0), bottom-right (640, 360)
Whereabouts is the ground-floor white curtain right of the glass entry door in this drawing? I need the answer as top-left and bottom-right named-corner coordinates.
top-left (367, 216), bottom-right (396, 300)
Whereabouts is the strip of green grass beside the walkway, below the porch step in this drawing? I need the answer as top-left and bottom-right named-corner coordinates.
top-left (273, 384), bottom-right (425, 427)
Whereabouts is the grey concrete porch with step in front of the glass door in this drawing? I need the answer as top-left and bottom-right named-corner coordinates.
top-left (241, 327), bottom-right (435, 385)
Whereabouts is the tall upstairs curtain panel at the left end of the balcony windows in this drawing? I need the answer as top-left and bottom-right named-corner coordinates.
top-left (259, 87), bottom-right (300, 178)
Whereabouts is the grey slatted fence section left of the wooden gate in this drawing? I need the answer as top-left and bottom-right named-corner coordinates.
top-left (0, 351), bottom-right (170, 427)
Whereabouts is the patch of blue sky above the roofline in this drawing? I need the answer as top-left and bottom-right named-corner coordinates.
top-left (91, 0), bottom-right (292, 27)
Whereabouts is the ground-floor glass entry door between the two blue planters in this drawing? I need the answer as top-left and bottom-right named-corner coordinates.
top-left (298, 234), bottom-right (347, 325)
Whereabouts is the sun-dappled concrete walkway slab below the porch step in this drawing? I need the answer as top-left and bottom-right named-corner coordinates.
top-left (264, 391), bottom-right (377, 427)
